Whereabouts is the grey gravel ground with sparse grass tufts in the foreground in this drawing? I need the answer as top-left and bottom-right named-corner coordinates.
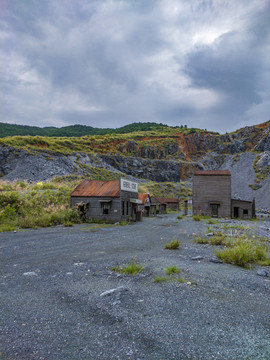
top-left (0, 214), bottom-right (270, 360)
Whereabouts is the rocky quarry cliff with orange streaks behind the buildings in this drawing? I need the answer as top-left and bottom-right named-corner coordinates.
top-left (0, 121), bottom-right (270, 209)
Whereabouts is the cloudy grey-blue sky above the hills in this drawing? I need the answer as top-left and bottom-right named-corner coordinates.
top-left (0, 0), bottom-right (270, 133)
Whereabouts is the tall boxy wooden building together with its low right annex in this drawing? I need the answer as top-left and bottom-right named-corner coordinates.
top-left (192, 170), bottom-right (256, 219)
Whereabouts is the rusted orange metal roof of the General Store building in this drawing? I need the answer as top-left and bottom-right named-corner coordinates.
top-left (70, 180), bottom-right (120, 197)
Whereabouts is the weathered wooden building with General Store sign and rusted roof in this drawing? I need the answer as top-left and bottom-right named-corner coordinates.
top-left (70, 178), bottom-right (140, 222)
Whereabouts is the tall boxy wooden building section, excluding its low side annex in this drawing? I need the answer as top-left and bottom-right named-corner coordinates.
top-left (192, 170), bottom-right (231, 218)
